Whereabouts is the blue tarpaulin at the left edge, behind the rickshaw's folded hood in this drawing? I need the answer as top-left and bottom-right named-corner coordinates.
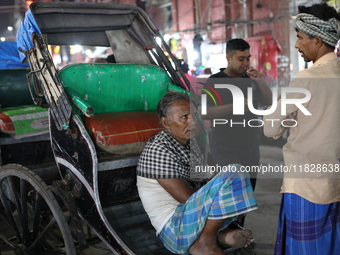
top-left (0, 42), bottom-right (29, 69)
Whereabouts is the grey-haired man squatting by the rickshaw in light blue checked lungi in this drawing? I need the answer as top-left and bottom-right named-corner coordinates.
top-left (137, 92), bottom-right (257, 255)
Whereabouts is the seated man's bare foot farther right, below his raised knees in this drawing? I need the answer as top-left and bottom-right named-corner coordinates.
top-left (217, 229), bottom-right (253, 248)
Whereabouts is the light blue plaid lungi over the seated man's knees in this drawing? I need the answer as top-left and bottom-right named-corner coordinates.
top-left (159, 166), bottom-right (257, 254)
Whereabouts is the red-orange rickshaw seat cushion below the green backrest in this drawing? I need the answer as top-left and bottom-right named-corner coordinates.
top-left (82, 111), bottom-right (163, 154)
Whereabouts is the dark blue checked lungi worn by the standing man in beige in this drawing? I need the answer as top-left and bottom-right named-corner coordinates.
top-left (275, 193), bottom-right (340, 255)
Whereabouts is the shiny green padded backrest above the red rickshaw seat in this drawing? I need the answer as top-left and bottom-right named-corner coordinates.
top-left (59, 63), bottom-right (171, 115)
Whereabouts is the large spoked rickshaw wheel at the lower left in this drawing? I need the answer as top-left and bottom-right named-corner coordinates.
top-left (0, 164), bottom-right (76, 255)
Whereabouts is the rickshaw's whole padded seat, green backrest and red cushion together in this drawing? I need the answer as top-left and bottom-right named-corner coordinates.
top-left (59, 63), bottom-right (184, 154)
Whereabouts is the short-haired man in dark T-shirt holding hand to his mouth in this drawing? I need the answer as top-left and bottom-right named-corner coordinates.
top-left (203, 39), bottom-right (272, 188)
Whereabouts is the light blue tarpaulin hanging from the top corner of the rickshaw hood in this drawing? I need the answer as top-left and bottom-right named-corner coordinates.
top-left (17, 9), bottom-right (41, 62)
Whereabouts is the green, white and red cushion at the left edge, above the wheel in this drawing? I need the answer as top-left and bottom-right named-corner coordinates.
top-left (0, 105), bottom-right (49, 136)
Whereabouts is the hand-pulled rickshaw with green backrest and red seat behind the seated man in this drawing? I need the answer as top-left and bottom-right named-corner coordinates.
top-left (0, 2), bottom-right (255, 255)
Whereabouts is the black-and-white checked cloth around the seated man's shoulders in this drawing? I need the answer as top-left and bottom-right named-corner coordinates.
top-left (137, 130), bottom-right (203, 182)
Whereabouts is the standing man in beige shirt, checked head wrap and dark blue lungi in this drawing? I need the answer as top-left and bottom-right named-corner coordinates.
top-left (264, 4), bottom-right (340, 255)
